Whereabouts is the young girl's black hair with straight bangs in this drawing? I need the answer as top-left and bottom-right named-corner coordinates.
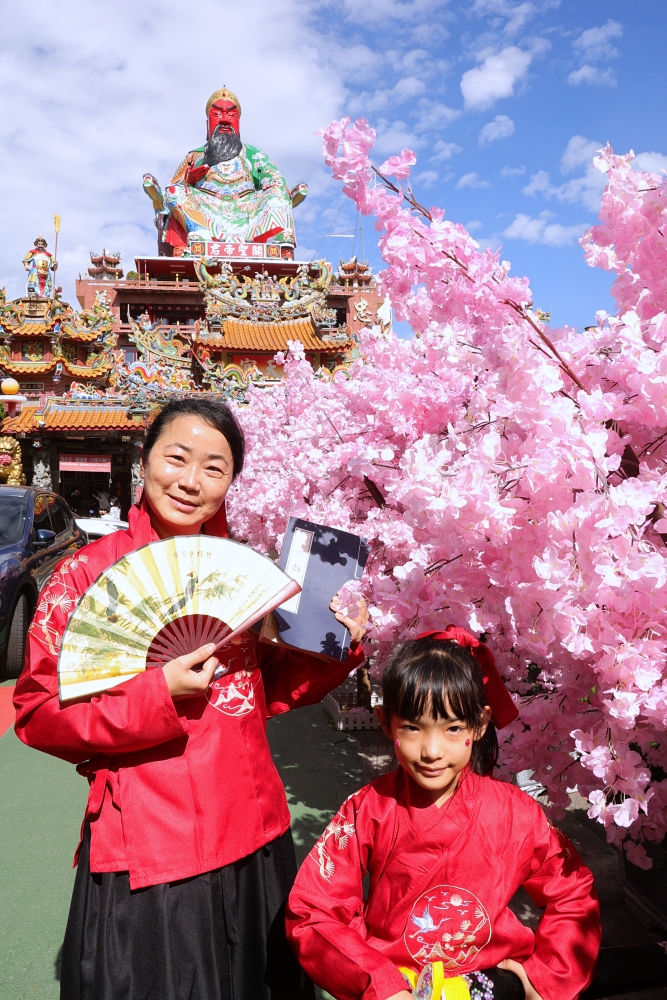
top-left (382, 638), bottom-right (498, 774)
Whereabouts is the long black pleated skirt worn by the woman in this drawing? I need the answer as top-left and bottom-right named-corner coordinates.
top-left (60, 827), bottom-right (314, 1000)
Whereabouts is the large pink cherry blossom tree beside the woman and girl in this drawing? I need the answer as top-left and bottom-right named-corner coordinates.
top-left (230, 118), bottom-right (667, 867)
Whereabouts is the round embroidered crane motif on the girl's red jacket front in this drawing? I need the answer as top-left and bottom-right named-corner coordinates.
top-left (404, 885), bottom-right (491, 971)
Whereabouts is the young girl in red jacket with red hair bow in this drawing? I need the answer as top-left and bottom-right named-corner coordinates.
top-left (287, 629), bottom-right (601, 1000)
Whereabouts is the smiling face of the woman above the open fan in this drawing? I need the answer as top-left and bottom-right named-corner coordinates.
top-left (142, 414), bottom-right (234, 538)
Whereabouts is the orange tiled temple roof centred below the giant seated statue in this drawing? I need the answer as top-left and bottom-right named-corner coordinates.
top-left (197, 318), bottom-right (349, 354)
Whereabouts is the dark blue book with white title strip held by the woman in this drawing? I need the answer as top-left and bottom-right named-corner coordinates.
top-left (261, 517), bottom-right (368, 662)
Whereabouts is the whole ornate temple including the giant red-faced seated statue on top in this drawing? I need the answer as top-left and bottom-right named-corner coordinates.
top-left (0, 88), bottom-right (390, 512)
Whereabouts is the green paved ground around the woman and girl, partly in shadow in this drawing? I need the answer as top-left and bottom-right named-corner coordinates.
top-left (0, 686), bottom-right (667, 1000)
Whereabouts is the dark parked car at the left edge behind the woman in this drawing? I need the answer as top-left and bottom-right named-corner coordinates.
top-left (0, 486), bottom-right (86, 679)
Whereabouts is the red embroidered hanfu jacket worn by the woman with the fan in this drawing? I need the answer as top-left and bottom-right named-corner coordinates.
top-left (14, 501), bottom-right (364, 889)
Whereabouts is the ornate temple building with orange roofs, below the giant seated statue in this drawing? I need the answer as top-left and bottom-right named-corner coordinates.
top-left (0, 253), bottom-right (389, 515)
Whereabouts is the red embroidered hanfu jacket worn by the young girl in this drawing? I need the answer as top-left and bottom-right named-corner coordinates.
top-left (287, 768), bottom-right (601, 1000)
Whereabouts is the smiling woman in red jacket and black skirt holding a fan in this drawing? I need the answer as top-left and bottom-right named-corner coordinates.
top-left (15, 398), bottom-right (365, 1000)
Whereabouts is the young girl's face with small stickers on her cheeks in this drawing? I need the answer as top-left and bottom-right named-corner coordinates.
top-left (376, 706), bottom-right (490, 806)
